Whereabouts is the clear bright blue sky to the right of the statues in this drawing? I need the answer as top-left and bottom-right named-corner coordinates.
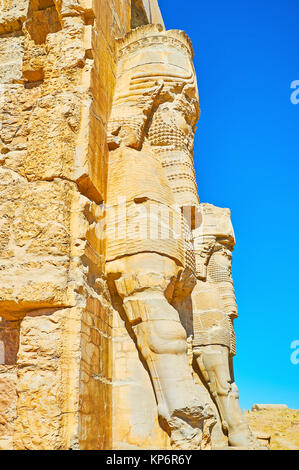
top-left (159, 0), bottom-right (299, 409)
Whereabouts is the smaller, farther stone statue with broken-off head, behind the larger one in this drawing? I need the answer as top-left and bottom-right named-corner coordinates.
top-left (192, 204), bottom-right (255, 447)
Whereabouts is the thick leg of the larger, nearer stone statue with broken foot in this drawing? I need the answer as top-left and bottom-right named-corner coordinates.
top-left (107, 253), bottom-right (216, 448)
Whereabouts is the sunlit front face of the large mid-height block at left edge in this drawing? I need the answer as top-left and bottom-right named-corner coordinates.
top-left (0, 170), bottom-right (74, 315)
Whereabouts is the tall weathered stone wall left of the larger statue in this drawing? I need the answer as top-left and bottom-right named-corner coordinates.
top-left (0, 0), bottom-right (131, 449)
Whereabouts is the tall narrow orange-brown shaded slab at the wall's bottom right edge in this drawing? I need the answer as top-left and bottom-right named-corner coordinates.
top-left (79, 297), bottom-right (113, 450)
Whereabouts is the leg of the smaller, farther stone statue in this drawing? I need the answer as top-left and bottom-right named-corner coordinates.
top-left (194, 344), bottom-right (255, 447)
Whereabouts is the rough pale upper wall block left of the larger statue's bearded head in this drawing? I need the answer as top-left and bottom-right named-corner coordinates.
top-left (16, 83), bottom-right (102, 203)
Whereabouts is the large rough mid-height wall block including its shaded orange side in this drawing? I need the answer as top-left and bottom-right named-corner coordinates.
top-left (0, 169), bottom-right (105, 316)
